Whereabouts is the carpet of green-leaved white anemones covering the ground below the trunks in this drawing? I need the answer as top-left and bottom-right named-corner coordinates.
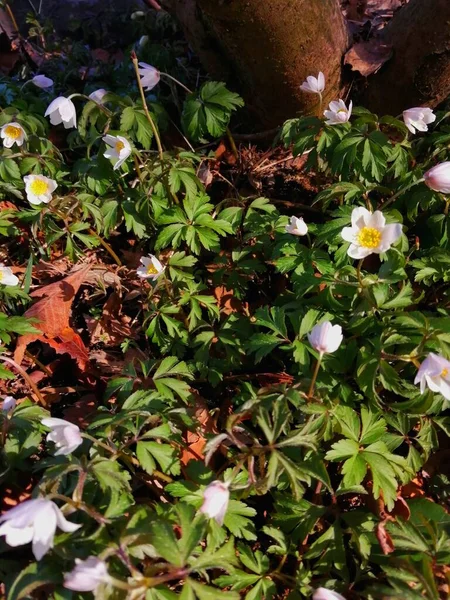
top-left (0, 4), bottom-right (450, 600)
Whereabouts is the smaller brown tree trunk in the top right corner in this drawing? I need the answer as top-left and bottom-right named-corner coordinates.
top-left (360, 0), bottom-right (450, 115)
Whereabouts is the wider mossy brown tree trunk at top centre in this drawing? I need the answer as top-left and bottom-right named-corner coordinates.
top-left (166, 0), bottom-right (348, 126)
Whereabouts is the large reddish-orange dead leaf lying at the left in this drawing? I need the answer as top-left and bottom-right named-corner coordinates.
top-left (14, 265), bottom-right (91, 369)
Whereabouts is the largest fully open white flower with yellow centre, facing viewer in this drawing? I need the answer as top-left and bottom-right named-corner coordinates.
top-left (341, 206), bottom-right (402, 259)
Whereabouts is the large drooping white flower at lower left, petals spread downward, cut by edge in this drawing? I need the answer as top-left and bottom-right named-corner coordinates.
top-left (0, 498), bottom-right (81, 560)
